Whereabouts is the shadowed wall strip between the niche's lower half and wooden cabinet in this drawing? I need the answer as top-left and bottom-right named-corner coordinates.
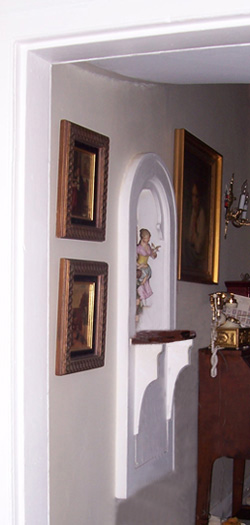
top-left (116, 349), bottom-right (198, 525)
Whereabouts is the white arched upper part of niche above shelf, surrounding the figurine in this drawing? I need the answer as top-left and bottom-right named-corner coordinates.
top-left (121, 153), bottom-right (176, 337)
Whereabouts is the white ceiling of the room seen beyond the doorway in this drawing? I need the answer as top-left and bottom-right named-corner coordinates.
top-left (87, 45), bottom-right (250, 84)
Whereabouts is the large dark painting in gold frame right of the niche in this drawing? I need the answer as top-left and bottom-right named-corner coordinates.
top-left (174, 129), bottom-right (223, 284)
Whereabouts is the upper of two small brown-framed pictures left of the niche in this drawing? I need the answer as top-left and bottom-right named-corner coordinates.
top-left (56, 120), bottom-right (109, 241)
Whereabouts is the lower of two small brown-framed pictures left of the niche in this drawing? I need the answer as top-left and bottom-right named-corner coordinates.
top-left (56, 259), bottom-right (108, 375)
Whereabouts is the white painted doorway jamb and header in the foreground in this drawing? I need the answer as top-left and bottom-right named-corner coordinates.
top-left (13, 20), bottom-right (250, 525)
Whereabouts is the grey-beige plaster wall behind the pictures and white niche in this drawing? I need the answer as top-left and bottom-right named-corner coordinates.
top-left (50, 65), bottom-right (249, 525)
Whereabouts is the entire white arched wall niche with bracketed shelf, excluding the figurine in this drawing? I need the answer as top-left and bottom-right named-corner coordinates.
top-left (116, 153), bottom-right (195, 499)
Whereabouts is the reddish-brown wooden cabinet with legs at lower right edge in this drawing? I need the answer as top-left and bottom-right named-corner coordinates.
top-left (196, 348), bottom-right (250, 525)
